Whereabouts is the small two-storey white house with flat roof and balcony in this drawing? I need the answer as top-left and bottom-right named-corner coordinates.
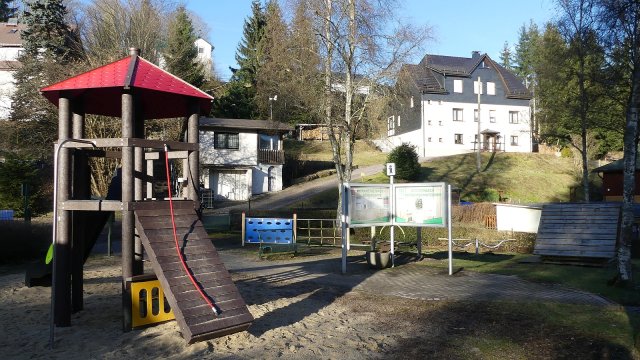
top-left (200, 118), bottom-right (293, 201)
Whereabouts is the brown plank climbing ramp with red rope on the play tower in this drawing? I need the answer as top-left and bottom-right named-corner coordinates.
top-left (135, 201), bottom-right (253, 343)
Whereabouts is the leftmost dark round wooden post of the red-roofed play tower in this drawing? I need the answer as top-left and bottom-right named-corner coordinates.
top-left (52, 94), bottom-right (71, 326)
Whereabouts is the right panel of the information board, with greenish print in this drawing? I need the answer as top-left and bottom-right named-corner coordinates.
top-left (393, 183), bottom-right (447, 227)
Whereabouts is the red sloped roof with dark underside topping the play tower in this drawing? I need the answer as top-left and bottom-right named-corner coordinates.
top-left (40, 56), bottom-right (213, 119)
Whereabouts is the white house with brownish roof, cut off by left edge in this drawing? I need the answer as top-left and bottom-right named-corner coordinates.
top-left (0, 19), bottom-right (26, 120)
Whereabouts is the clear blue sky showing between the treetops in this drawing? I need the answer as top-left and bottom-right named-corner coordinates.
top-left (186, 0), bottom-right (554, 80)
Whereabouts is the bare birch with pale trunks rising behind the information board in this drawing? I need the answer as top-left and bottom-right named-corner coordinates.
top-left (313, 0), bottom-right (431, 212)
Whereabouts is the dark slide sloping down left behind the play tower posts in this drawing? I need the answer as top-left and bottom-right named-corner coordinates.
top-left (24, 170), bottom-right (122, 287)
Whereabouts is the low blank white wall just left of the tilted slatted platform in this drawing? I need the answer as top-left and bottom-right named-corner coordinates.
top-left (495, 204), bottom-right (542, 233)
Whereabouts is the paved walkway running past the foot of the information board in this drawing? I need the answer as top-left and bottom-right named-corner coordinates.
top-left (220, 249), bottom-right (615, 306)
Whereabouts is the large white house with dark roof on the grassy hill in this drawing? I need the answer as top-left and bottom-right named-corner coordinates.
top-left (387, 51), bottom-right (532, 157)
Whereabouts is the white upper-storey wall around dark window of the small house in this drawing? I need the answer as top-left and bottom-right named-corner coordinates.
top-left (200, 130), bottom-right (258, 166)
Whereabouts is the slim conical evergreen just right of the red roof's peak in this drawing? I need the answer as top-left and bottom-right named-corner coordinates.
top-left (164, 6), bottom-right (205, 87)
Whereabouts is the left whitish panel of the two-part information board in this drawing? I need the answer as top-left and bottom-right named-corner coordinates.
top-left (346, 184), bottom-right (391, 226)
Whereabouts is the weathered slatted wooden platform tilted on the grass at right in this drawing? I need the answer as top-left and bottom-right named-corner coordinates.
top-left (533, 202), bottom-right (620, 260)
